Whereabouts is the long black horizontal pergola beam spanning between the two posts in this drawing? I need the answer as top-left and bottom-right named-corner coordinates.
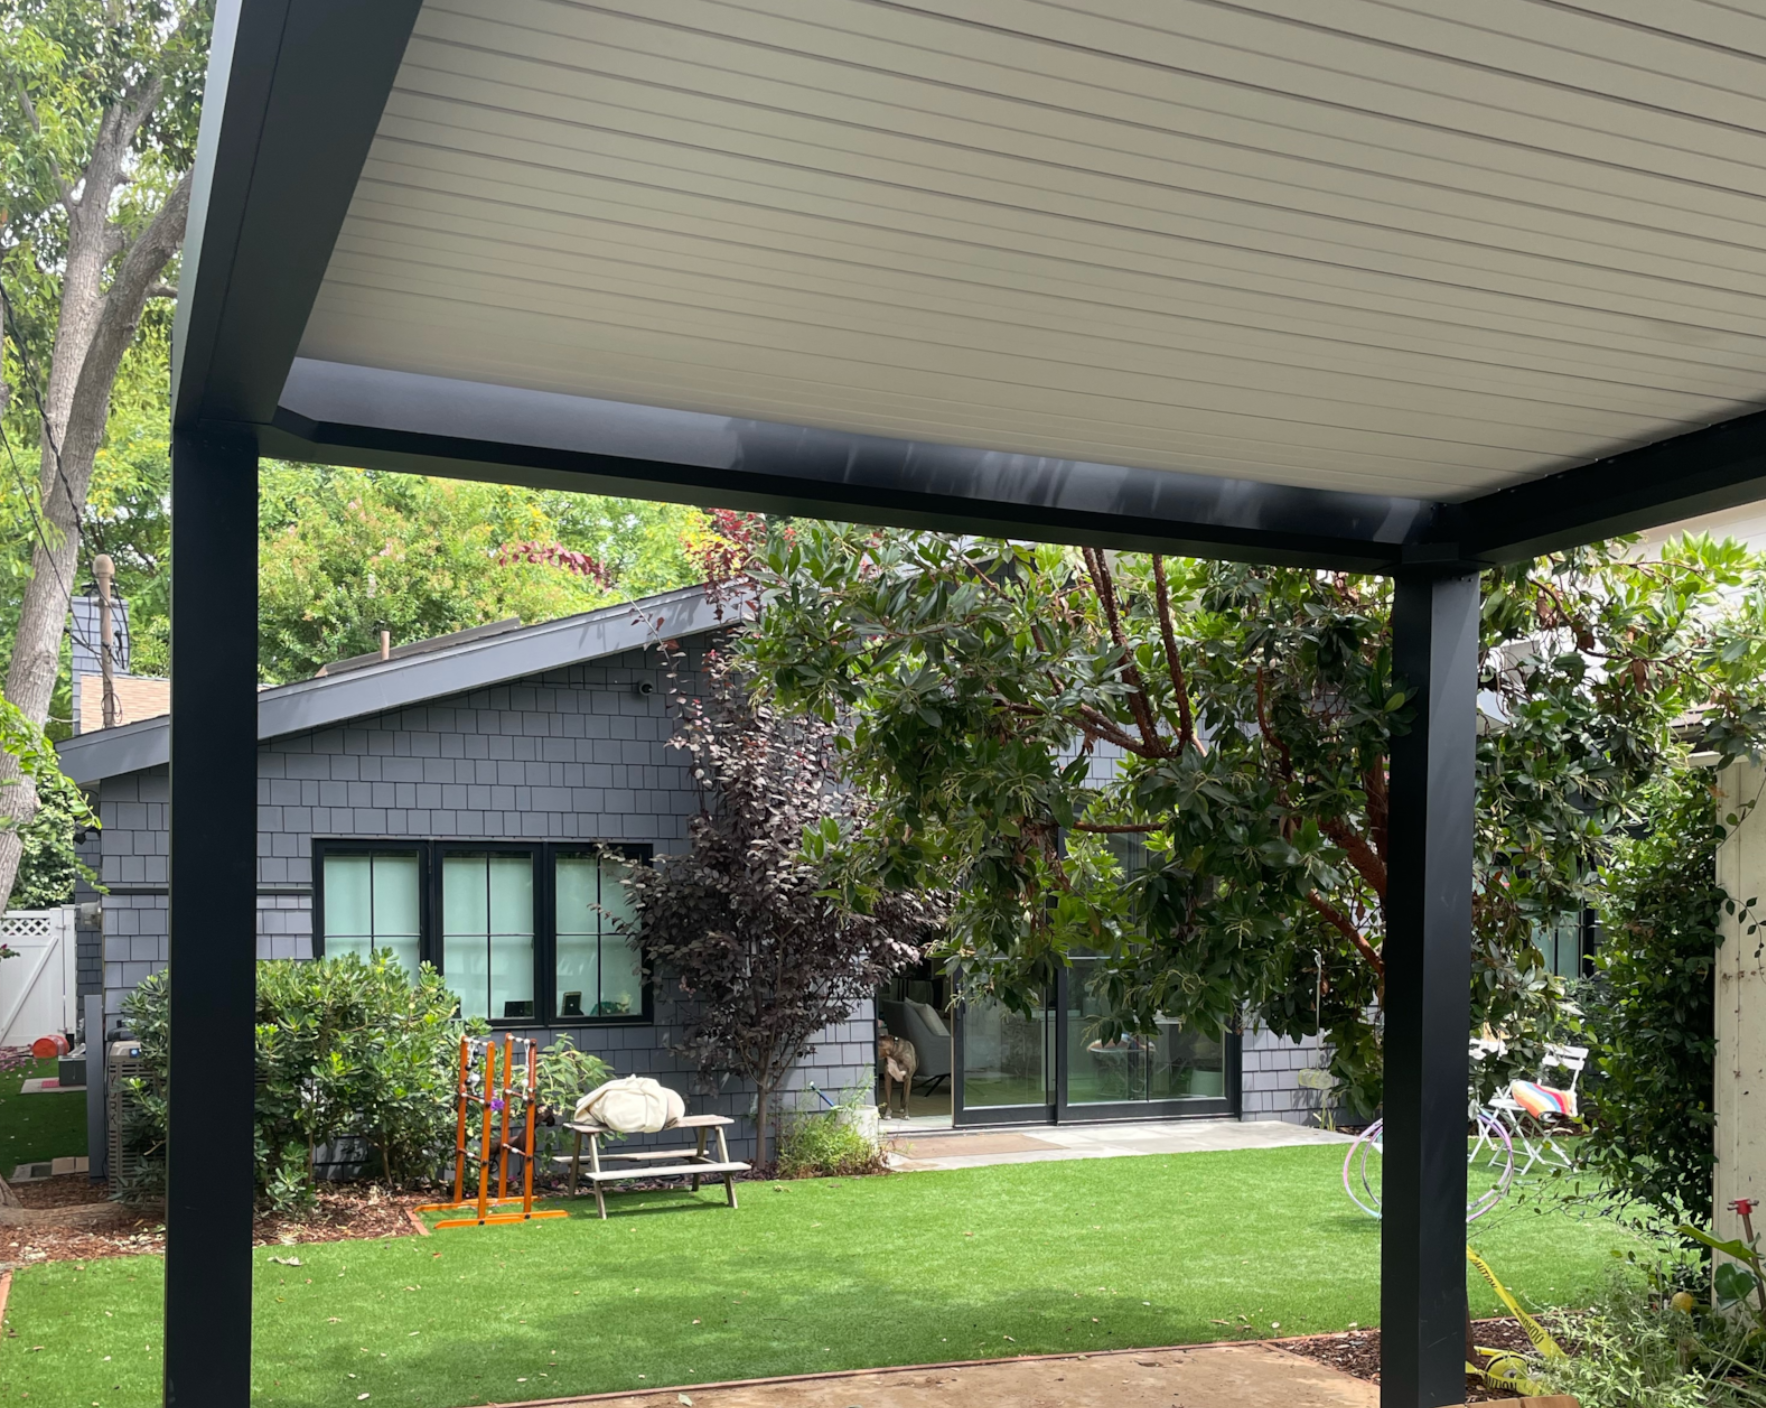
top-left (258, 359), bottom-right (1452, 572)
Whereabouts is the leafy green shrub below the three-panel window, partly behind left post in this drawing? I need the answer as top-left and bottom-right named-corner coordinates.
top-left (124, 954), bottom-right (482, 1207)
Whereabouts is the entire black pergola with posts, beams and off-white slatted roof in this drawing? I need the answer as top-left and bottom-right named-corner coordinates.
top-left (166, 0), bottom-right (1766, 1408)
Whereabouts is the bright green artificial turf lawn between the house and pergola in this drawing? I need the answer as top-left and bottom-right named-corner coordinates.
top-left (0, 1145), bottom-right (1628, 1408)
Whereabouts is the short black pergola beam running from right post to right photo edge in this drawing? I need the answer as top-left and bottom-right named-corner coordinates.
top-left (1460, 412), bottom-right (1766, 562)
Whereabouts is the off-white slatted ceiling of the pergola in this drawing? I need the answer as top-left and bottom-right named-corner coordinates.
top-left (302, 0), bottom-right (1766, 498)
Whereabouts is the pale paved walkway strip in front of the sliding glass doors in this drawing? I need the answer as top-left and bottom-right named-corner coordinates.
top-left (883, 1120), bottom-right (1353, 1171)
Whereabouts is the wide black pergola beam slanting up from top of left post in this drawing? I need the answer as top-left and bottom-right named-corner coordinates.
top-left (171, 0), bottom-right (422, 426)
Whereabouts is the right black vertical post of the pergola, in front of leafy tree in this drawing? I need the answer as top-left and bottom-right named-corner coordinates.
top-left (1379, 567), bottom-right (1478, 1408)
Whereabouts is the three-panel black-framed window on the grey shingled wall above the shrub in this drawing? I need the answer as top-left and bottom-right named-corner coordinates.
top-left (313, 839), bottom-right (652, 1026)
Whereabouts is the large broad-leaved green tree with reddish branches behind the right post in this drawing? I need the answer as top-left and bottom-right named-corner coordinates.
top-left (745, 526), bottom-right (1761, 1101)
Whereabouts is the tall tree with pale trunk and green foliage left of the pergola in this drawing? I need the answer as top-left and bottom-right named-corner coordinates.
top-left (0, 0), bottom-right (214, 908)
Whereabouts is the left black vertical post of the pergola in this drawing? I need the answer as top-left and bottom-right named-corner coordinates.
top-left (164, 431), bottom-right (258, 1408)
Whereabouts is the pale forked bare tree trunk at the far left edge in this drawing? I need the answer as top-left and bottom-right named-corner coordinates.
top-left (0, 151), bottom-right (191, 912)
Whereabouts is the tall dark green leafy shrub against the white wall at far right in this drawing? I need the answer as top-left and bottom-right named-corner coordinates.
top-left (1579, 770), bottom-right (1727, 1223)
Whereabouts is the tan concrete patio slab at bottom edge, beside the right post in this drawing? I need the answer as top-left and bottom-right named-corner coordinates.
top-left (525, 1344), bottom-right (1379, 1408)
